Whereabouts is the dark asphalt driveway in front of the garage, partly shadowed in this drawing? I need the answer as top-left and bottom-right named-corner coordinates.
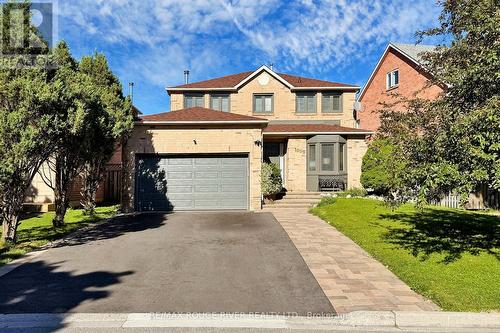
top-left (0, 212), bottom-right (334, 315)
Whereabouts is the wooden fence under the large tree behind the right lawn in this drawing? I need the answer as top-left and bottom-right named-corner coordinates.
top-left (434, 185), bottom-right (500, 209)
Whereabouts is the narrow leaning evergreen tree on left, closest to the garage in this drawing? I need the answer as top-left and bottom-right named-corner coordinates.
top-left (79, 54), bottom-right (134, 215)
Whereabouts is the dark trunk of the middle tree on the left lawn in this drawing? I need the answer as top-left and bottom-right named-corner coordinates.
top-left (52, 157), bottom-right (73, 228)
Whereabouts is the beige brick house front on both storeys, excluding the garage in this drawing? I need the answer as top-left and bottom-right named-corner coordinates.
top-left (166, 71), bottom-right (366, 198)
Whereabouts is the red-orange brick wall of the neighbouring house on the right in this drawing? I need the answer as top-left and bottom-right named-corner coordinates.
top-left (357, 49), bottom-right (442, 131)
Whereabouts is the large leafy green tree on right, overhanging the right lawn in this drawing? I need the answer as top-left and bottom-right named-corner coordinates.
top-left (381, 0), bottom-right (500, 203)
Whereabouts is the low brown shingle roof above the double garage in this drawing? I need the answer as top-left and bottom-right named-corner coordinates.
top-left (138, 107), bottom-right (268, 124)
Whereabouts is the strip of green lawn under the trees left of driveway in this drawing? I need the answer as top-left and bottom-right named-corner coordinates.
top-left (0, 206), bottom-right (117, 265)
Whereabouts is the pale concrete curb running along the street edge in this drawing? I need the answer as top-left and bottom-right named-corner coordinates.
top-left (0, 311), bottom-right (500, 330)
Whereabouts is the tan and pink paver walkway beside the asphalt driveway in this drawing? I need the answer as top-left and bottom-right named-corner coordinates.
top-left (265, 208), bottom-right (439, 314)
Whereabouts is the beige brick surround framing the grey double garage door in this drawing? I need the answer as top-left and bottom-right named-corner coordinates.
top-left (123, 125), bottom-right (262, 212)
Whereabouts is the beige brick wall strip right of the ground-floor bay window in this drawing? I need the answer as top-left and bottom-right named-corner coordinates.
top-left (347, 136), bottom-right (368, 189)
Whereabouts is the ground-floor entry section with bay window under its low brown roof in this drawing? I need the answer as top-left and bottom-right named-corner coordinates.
top-left (263, 124), bottom-right (371, 192)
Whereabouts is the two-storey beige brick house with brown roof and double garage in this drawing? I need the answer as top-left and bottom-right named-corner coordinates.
top-left (123, 66), bottom-right (371, 211)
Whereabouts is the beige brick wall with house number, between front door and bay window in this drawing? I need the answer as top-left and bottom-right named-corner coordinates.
top-left (285, 138), bottom-right (307, 192)
